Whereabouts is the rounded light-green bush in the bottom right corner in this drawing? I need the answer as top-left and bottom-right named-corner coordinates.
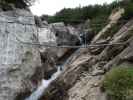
top-left (103, 67), bottom-right (133, 100)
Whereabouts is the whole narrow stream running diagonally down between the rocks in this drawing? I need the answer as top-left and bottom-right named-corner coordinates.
top-left (25, 48), bottom-right (80, 100)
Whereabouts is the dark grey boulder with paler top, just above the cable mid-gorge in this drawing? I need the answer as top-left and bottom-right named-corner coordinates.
top-left (51, 22), bottom-right (79, 45)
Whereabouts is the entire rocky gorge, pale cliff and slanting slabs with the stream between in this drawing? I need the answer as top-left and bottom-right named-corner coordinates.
top-left (0, 1), bottom-right (133, 100)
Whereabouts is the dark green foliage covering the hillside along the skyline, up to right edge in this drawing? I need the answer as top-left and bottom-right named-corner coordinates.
top-left (41, 0), bottom-right (133, 34)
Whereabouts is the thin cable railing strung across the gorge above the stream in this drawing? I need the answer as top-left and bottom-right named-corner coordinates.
top-left (0, 17), bottom-right (129, 48)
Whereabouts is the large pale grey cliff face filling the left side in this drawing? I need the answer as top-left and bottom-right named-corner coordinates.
top-left (0, 10), bottom-right (41, 100)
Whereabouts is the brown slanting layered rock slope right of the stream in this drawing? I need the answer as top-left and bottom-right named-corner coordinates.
top-left (40, 9), bottom-right (133, 100)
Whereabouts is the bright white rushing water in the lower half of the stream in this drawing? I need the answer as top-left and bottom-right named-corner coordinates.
top-left (25, 67), bottom-right (61, 100)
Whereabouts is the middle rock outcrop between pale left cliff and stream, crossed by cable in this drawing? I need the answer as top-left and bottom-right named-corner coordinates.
top-left (39, 22), bottom-right (79, 79)
